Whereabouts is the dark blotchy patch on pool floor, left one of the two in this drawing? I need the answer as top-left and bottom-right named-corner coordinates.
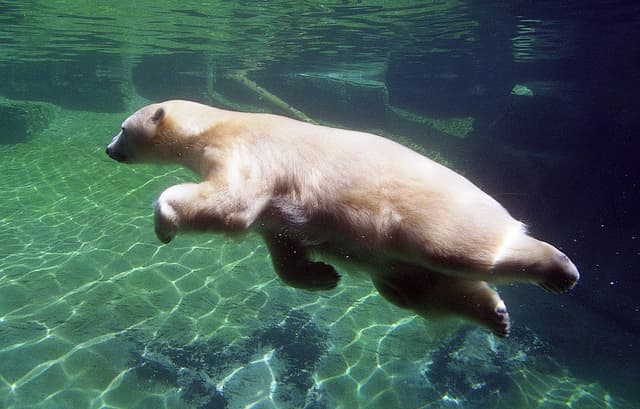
top-left (129, 310), bottom-right (327, 409)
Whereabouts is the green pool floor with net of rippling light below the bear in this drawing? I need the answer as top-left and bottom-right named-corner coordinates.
top-left (0, 111), bottom-right (625, 409)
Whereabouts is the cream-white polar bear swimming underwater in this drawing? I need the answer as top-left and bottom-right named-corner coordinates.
top-left (107, 100), bottom-right (579, 337)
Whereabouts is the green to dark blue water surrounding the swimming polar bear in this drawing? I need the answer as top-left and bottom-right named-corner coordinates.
top-left (0, 1), bottom-right (640, 409)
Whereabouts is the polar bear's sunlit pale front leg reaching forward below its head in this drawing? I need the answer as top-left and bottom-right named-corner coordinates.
top-left (154, 182), bottom-right (266, 243)
